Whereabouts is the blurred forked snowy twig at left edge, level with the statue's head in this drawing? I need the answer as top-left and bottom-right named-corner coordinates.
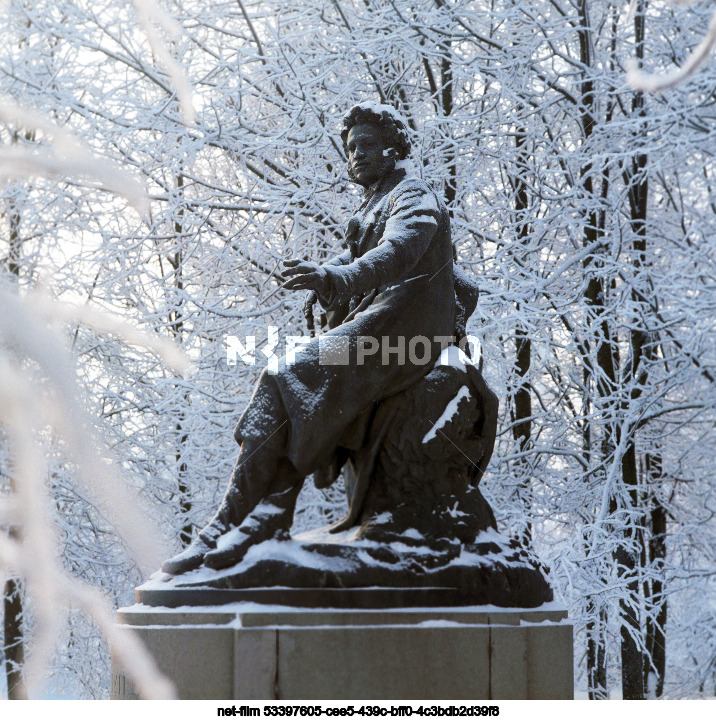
top-left (0, 97), bottom-right (149, 214)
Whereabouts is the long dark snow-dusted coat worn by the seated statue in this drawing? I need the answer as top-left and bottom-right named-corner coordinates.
top-left (235, 168), bottom-right (456, 495)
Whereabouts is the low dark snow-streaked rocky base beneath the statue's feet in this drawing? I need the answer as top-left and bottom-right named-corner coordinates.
top-left (144, 518), bottom-right (553, 608)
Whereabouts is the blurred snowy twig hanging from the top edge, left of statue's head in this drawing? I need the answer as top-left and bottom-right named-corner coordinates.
top-left (133, 0), bottom-right (196, 125)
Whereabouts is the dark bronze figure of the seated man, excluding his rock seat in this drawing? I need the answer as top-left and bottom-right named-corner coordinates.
top-left (162, 103), bottom-right (486, 574)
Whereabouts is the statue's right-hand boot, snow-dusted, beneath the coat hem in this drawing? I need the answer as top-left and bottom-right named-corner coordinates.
top-left (204, 459), bottom-right (303, 569)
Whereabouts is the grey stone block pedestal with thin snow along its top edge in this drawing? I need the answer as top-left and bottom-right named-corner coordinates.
top-left (111, 589), bottom-right (573, 705)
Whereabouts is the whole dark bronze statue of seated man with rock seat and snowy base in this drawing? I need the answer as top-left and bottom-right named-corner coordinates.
top-left (162, 103), bottom-right (551, 605)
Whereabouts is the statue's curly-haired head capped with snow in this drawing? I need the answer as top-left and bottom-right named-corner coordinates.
top-left (341, 103), bottom-right (410, 186)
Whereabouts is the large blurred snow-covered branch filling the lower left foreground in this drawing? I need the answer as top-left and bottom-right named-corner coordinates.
top-left (0, 291), bottom-right (186, 698)
